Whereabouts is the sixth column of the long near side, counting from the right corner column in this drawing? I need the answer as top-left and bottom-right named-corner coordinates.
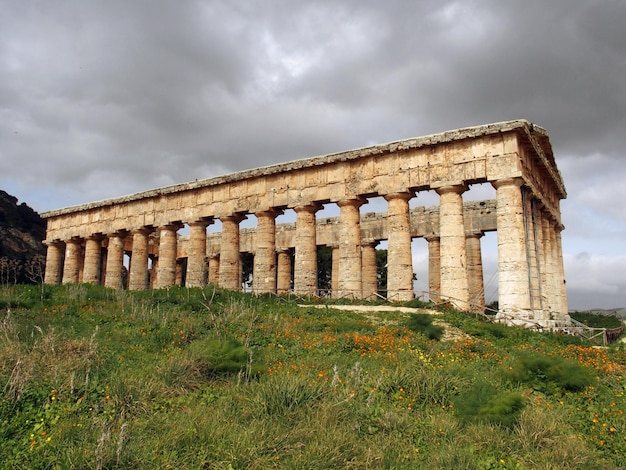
top-left (252, 210), bottom-right (277, 294)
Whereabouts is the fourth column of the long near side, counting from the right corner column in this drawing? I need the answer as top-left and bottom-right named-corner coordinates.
top-left (333, 199), bottom-right (363, 299)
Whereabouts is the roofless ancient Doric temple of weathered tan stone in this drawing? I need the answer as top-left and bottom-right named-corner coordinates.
top-left (37, 120), bottom-right (569, 328)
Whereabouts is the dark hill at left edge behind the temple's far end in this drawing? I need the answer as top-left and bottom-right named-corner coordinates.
top-left (0, 190), bottom-right (46, 283)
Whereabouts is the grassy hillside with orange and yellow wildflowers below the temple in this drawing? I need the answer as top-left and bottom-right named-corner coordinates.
top-left (0, 285), bottom-right (626, 469)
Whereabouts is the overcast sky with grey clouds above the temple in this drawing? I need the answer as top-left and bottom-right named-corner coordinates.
top-left (0, 0), bottom-right (626, 309)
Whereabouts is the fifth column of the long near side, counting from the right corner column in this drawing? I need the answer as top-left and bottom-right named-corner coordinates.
top-left (293, 204), bottom-right (320, 295)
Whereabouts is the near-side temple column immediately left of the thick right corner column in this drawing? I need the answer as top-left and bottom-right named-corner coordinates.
top-left (436, 185), bottom-right (469, 311)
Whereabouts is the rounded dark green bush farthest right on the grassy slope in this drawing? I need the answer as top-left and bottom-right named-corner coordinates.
top-left (506, 353), bottom-right (595, 393)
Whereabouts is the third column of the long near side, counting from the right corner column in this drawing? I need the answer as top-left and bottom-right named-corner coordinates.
top-left (385, 193), bottom-right (414, 301)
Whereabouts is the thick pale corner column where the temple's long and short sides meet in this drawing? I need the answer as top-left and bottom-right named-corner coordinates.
top-left (492, 178), bottom-right (532, 319)
